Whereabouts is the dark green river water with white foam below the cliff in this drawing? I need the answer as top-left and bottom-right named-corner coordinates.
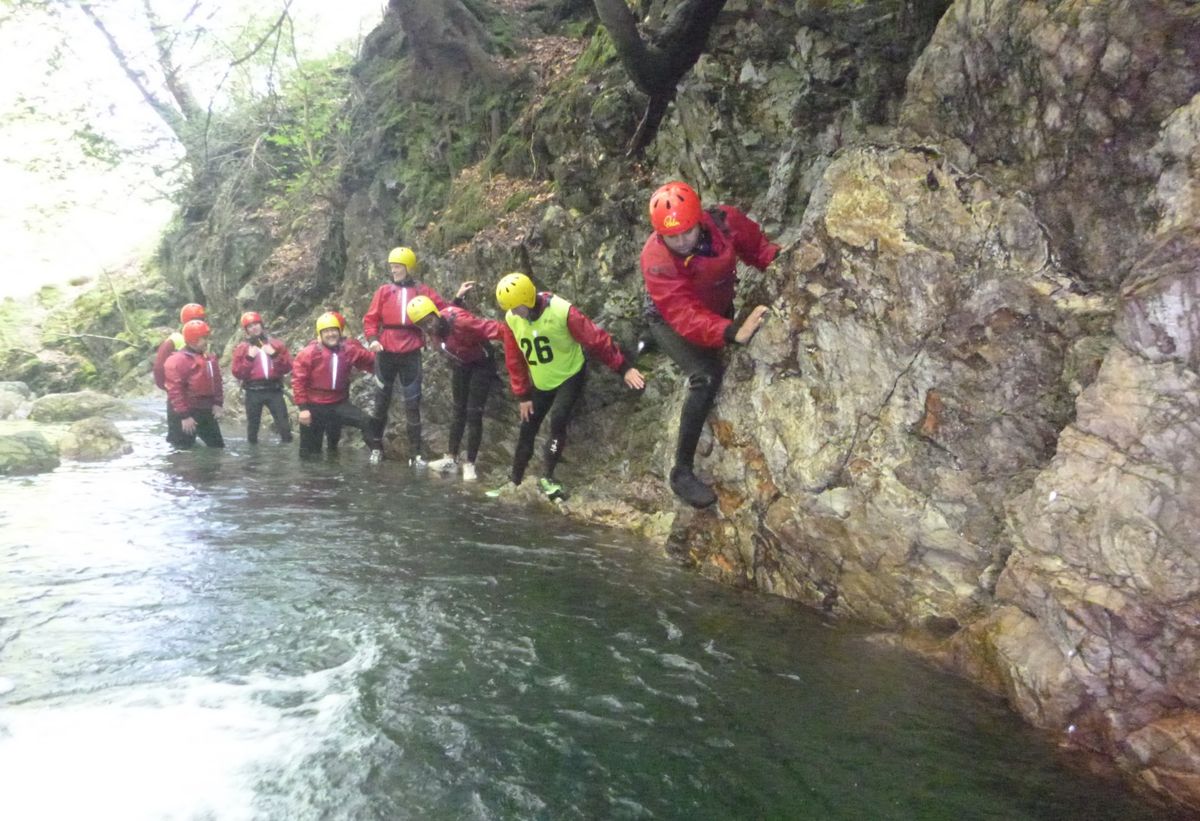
top-left (0, 410), bottom-right (1163, 821)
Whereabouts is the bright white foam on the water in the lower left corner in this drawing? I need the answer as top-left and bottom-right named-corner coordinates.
top-left (0, 645), bottom-right (377, 821)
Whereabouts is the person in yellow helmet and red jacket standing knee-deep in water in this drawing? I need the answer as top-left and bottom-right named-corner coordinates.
top-left (292, 313), bottom-right (383, 457)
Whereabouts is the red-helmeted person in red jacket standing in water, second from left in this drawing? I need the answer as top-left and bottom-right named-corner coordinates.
top-left (163, 319), bottom-right (224, 449)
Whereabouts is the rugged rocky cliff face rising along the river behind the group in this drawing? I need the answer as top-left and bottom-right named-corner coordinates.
top-left (147, 0), bottom-right (1200, 808)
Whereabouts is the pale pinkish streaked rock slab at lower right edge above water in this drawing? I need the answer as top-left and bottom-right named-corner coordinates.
top-left (996, 347), bottom-right (1200, 798)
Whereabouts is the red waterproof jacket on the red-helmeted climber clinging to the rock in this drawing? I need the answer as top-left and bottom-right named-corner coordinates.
top-left (642, 205), bottom-right (779, 348)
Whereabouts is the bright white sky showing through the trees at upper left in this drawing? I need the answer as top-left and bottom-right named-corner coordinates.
top-left (0, 0), bottom-right (385, 296)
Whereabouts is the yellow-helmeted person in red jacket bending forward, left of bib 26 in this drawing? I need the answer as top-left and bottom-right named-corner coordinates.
top-left (408, 296), bottom-right (503, 481)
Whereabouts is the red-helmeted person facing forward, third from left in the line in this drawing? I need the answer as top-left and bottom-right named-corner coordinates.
top-left (230, 311), bottom-right (292, 444)
